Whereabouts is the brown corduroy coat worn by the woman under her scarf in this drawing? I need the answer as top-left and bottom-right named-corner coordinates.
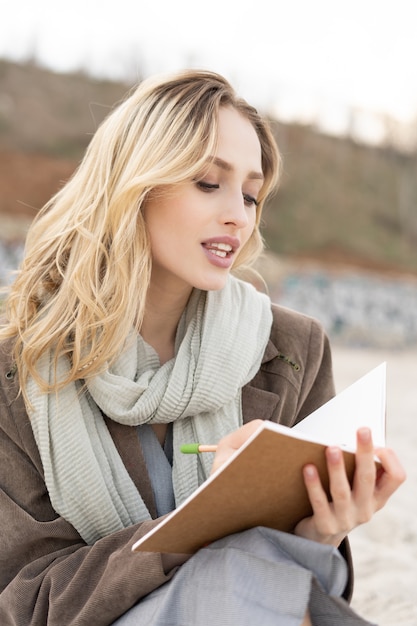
top-left (0, 305), bottom-right (352, 626)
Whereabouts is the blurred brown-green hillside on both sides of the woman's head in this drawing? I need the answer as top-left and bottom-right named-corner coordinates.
top-left (0, 61), bottom-right (417, 275)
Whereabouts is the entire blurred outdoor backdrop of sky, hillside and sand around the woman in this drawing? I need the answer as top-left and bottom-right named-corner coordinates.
top-left (0, 0), bottom-right (417, 626)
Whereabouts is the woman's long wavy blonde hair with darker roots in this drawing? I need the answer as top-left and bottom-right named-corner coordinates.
top-left (0, 70), bottom-right (280, 395)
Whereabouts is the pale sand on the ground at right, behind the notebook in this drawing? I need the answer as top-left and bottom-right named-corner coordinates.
top-left (333, 346), bottom-right (417, 626)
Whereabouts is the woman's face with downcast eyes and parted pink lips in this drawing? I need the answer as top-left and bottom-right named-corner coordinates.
top-left (144, 107), bottom-right (263, 292)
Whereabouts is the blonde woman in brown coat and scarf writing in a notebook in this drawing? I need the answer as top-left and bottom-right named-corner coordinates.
top-left (0, 71), bottom-right (404, 626)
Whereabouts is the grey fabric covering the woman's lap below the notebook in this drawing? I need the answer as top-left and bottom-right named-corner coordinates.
top-left (114, 528), bottom-right (370, 626)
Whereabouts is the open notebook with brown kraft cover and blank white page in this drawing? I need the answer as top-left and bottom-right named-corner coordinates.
top-left (132, 363), bottom-right (386, 553)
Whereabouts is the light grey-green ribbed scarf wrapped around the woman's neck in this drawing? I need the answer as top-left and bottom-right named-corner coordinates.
top-left (27, 277), bottom-right (272, 544)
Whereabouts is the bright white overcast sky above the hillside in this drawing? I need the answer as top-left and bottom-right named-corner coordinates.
top-left (0, 0), bottom-right (417, 140)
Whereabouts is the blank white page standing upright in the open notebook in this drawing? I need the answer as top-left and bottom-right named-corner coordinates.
top-left (293, 363), bottom-right (386, 450)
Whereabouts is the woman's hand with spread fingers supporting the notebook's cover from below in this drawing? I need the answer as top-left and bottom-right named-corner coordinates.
top-left (294, 428), bottom-right (406, 546)
